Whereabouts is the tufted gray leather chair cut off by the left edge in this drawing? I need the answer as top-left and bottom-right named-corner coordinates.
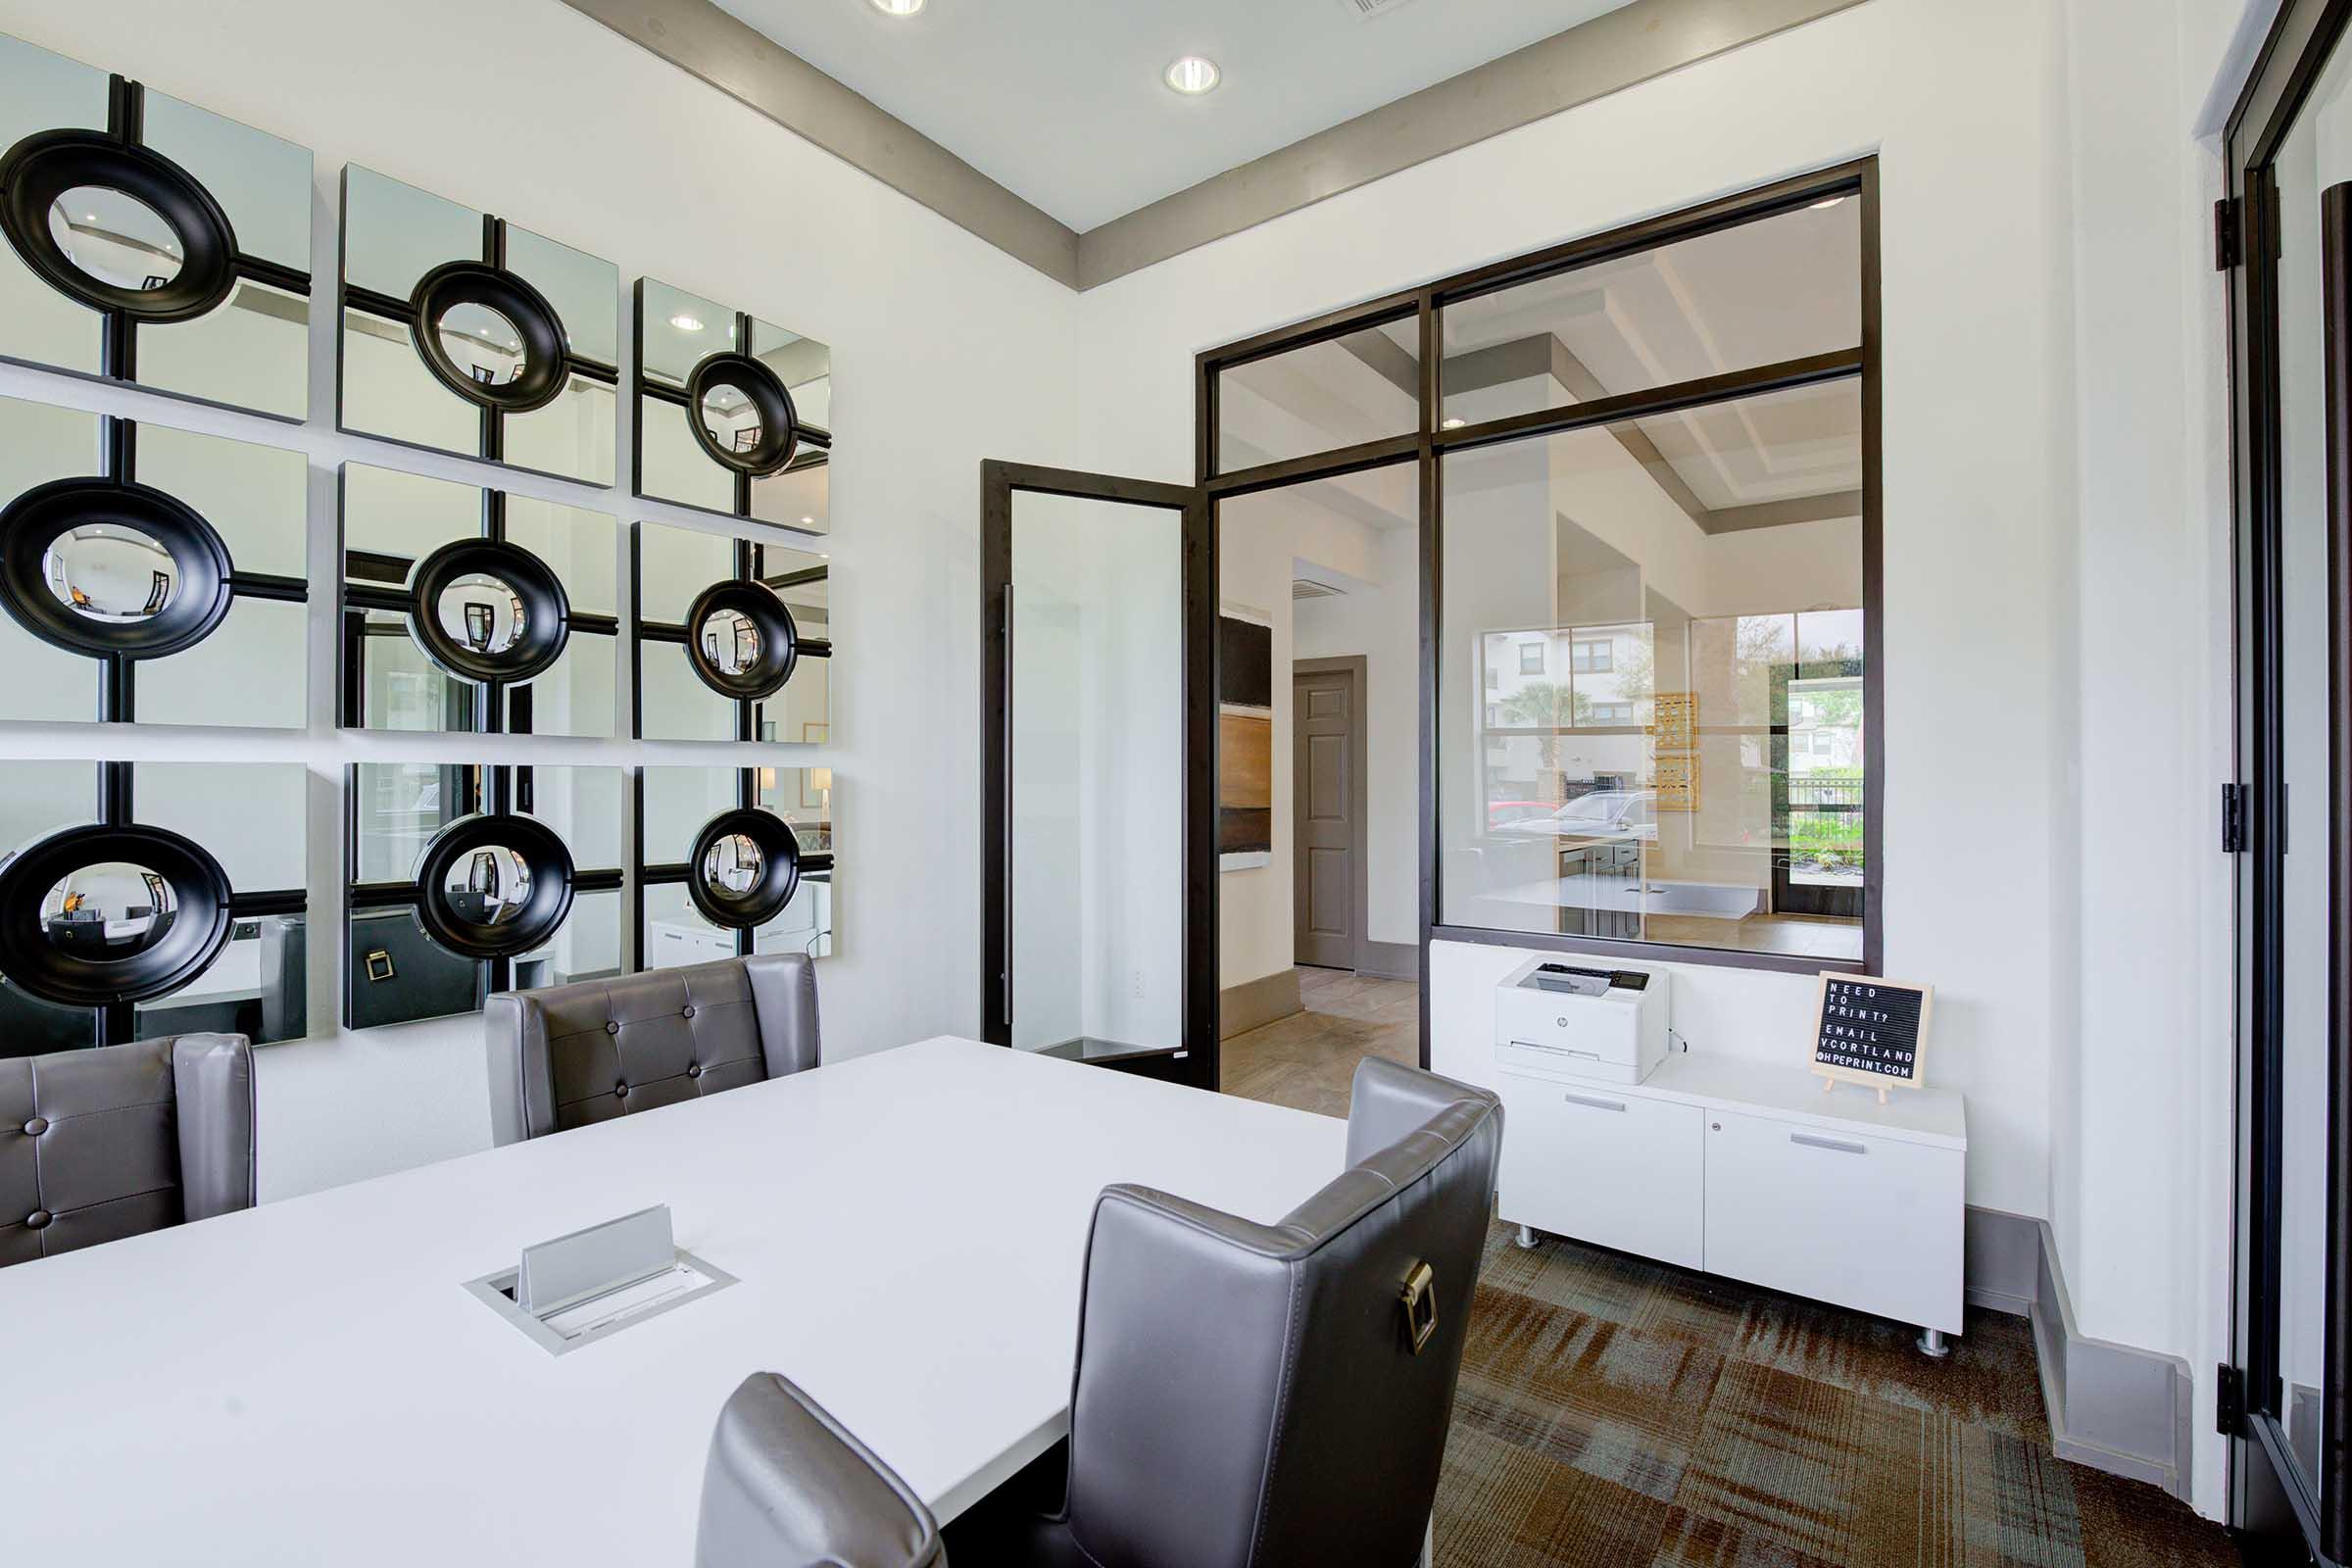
top-left (0, 1034), bottom-right (254, 1267)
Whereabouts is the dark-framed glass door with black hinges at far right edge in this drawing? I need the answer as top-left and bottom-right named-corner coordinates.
top-left (2223, 0), bottom-right (2352, 1563)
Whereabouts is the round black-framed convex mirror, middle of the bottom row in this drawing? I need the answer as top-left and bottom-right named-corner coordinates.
top-left (416, 813), bottom-right (571, 959)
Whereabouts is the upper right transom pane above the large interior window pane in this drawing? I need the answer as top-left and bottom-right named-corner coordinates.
top-left (1440, 195), bottom-right (1863, 423)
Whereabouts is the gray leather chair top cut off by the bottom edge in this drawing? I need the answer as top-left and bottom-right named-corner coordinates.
top-left (694, 1373), bottom-right (948, 1568)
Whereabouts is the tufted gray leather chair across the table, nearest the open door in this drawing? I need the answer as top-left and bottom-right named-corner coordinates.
top-left (484, 953), bottom-right (818, 1143)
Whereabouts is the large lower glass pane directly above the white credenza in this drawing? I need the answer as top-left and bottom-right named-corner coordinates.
top-left (1440, 381), bottom-right (1863, 959)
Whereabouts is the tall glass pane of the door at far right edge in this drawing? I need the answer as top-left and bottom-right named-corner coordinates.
top-left (2275, 27), bottom-right (2352, 1491)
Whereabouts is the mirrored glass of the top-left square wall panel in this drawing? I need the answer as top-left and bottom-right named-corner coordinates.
top-left (0, 37), bottom-right (311, 420)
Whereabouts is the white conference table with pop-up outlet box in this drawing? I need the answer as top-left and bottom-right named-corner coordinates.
top-left (0, 1037), bottom-right (1346, 1568)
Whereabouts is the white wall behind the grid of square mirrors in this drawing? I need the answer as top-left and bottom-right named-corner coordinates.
top-left (0, 0), bottom-right (1075, 1199)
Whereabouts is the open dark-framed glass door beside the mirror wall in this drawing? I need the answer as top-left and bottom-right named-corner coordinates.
top-left (981, 464), bottom-right (1216, 1086)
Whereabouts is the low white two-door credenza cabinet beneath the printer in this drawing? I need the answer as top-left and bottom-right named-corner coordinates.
top-left (1495, 1054), bottom-right (1969, 1333)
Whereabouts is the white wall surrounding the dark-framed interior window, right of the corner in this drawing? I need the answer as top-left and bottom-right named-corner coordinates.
top-left (1080, 0), bottom-right (2234, 1509)
